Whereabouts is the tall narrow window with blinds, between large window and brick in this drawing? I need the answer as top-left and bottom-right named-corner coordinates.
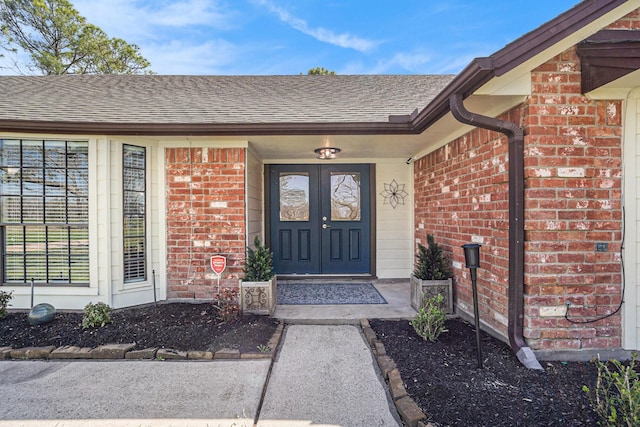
top-left (122, 145), bottom-right (147, 283)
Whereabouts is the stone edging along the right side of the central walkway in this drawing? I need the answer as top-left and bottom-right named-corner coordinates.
top-left (360, 319), bottom-right (435, 427)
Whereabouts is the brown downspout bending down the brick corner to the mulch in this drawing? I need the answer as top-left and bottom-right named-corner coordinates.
top-left (449, 93), bottom-right (542, 369)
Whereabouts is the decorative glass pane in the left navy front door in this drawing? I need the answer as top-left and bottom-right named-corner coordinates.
top-left (280, 172), bottom-right (309, 221)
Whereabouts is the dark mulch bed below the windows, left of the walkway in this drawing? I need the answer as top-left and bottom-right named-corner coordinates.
top-left (0, 303), bottom-right (279, 353)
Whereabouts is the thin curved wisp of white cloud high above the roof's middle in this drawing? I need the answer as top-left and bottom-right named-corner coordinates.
top-left (255, 0), bottom-right (378, 52)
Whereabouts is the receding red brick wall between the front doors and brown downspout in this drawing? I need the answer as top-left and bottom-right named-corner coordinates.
top-left (414, 115), bottom-right (520, 335)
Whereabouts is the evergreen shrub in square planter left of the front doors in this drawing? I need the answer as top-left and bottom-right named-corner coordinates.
top-left (240, 236), bottom-right (276, 315)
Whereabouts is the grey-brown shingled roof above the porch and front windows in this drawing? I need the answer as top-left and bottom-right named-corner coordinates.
top-left (0, 75), bottom-right (454, 134)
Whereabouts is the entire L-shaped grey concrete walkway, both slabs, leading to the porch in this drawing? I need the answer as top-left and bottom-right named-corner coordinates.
top-left (0, 325), bottom-right (401, 427)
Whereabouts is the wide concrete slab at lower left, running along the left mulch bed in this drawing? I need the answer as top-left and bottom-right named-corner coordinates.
top-left (0, 360), bottom-right (270, 427)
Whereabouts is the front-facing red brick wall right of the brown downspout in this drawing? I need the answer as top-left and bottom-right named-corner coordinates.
top-left (524, 49), bottom-right (623, 349)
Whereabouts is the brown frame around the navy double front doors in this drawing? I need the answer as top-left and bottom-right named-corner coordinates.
top-left (263, 163), bottom-right (377, 279)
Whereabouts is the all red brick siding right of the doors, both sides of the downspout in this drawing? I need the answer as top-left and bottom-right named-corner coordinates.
top-left (414, 10), bottom-right (640, 350)
